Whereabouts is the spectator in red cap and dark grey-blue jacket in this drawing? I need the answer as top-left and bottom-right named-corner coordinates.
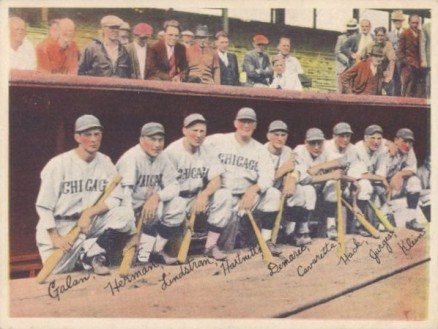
top-left (243, 34), bottom-right (272, 87)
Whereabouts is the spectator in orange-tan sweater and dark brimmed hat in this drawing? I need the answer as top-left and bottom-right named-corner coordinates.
top-left (186, 25), bottom-right (220, 85)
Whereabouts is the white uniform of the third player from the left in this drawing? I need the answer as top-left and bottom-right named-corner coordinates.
top-left (164, 137), bottom-right (231, 228)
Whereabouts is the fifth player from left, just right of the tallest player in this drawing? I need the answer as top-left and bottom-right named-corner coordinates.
top-left (265, 120), bottom-right (312, 247)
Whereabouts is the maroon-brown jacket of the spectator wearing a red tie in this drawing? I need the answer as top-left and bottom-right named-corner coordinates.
top-left (145, 40), bottom-right (188, 81)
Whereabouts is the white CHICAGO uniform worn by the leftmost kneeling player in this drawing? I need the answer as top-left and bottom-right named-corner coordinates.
top-left (36, 150), bottom-right (135, 273)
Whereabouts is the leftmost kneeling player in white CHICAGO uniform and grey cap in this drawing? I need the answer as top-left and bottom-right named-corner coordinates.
top-left (36, 114), bottom-right (135, 275)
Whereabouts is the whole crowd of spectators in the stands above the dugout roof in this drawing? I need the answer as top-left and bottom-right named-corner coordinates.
top-left (9, 11), bottom-right (430, 97)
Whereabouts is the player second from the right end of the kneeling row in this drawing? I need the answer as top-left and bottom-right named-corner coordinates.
top-left (355, 124), bottom-right (395, 231)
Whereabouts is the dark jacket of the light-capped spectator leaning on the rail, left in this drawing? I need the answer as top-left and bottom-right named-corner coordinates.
top-left (78, 39), bottom-right (132, 79)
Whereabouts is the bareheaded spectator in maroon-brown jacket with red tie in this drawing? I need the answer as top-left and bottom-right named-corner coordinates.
top-left (146, 20), bottom-right (188, 82)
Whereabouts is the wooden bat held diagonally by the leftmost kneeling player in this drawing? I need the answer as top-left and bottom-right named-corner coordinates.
top-left (37, 175), bottom-right (122, 283)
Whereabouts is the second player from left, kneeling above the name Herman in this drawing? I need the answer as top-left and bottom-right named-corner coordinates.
top-left (116, 122), bottom-right (185, 265)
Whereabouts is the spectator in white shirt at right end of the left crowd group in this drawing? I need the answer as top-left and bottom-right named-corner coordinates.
top-left (272, 37), bottom-right (304, 91)
